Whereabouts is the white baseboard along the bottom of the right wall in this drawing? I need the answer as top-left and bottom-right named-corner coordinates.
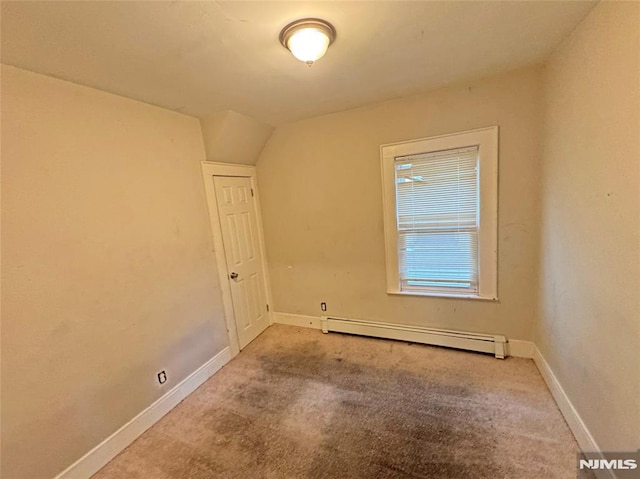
top-left (533, 344), bottom-right (616, 479)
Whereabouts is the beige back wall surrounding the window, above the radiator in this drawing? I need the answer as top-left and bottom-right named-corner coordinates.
top-left (257, 68), bottom-right (542, 340)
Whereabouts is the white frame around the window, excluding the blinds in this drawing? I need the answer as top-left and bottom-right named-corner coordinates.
top-left (380, 126), bottom-right (498, 301)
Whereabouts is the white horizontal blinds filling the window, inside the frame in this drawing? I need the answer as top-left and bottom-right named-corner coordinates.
top-left (395, 146), bottom-right (479, 294)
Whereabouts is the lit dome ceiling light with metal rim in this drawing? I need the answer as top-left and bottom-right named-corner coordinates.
top-left (280, 18), bottom-right (336, 66)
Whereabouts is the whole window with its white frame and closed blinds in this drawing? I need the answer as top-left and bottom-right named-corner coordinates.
top-left (381, 127), bottom-right (498, 299)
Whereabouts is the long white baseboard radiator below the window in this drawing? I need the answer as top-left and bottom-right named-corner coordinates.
top-left (320, 316), bottom-right (507, 359)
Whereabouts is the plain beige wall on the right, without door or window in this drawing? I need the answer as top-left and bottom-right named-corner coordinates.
top-left (535, 2), bottom-right (640, 450)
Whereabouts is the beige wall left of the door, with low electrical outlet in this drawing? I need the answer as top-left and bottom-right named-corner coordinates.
top-left (1, 66), bottom-right (227, 479)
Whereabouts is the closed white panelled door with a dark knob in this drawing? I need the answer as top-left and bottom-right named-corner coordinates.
top-left (214, 176), bottom-right (269, 349)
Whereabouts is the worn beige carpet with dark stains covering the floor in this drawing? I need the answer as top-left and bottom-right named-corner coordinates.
top-left (94, 325), bottom-right (578, 479)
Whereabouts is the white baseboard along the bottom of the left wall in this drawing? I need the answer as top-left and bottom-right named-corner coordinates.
top-left (55, 346), bottom-right (231, 479)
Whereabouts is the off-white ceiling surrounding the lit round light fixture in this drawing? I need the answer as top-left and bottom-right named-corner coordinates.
top-left (1, 1), bottom-right (595, 125)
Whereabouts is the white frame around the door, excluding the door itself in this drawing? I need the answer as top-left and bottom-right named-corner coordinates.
top-left (202, 161), bottom-right (273, 357)
